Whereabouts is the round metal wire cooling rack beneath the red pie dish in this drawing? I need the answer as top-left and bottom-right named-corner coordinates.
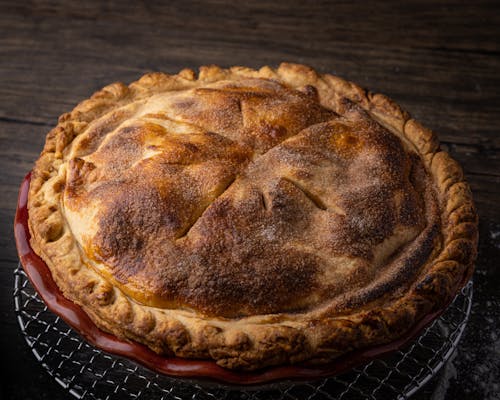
top-left (14, 266), bottom-right (473, 400)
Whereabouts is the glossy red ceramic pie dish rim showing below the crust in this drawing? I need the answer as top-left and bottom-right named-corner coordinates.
top-left (14, 173), bottom-right (468, 386)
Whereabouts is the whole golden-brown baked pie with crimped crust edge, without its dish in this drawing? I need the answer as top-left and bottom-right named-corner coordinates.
top-left (28, 64), bottom-right (477, 370)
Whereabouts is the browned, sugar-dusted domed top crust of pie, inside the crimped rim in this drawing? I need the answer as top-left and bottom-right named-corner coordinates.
top-left (59, 78), bottom-right (437, 317)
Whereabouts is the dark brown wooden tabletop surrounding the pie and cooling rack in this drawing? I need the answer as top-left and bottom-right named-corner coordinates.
top-left (0, 1), bottom-right (500, 399)
